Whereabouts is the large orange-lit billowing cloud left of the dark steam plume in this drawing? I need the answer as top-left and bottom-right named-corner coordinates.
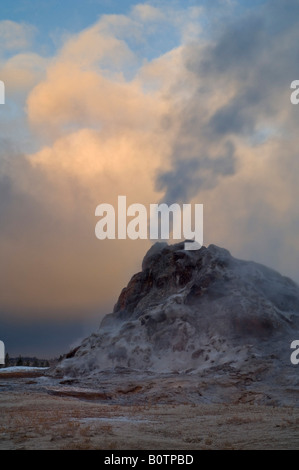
top-left (0, 6), bottom-right (176, 317)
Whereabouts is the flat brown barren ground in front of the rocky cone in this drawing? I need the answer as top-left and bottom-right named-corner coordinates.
top-left (0, 376), bottom-right (299, 450)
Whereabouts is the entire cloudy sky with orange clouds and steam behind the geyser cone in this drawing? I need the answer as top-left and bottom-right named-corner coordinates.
top-left (0, 0), bottom-right (299, 357)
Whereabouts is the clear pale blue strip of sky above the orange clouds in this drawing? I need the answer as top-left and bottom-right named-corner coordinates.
top-left (0, 0), bottom-right (265, 55)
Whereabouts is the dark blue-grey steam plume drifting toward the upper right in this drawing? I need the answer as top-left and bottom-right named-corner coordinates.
top-left (157, 0), bottom-right (299, 203)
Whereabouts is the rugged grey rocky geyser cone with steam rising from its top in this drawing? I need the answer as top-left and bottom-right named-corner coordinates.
top-left (55, 243), bottom-right (299, 376)
